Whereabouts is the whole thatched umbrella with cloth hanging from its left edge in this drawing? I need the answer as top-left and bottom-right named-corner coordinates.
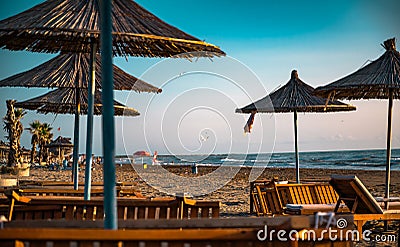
top-left (236, 70), bottom-right (356, 183)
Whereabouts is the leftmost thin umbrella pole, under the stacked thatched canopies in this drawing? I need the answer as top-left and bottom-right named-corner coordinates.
top-left (72, 85), bottom-right (81, 190)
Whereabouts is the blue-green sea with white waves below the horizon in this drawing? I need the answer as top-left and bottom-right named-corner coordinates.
top-left (126, 149), bottom-right (400, 170)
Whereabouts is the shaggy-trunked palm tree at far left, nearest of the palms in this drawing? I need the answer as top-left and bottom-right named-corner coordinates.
top-left (4, 100), bottom-right (26, 166)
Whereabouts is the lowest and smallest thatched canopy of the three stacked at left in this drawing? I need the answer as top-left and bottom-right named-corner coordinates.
top-left (15, 88), bottom-right (140, 116)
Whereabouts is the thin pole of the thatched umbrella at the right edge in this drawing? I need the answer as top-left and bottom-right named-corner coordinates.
top-left (385, 89), bottom-right (393, 209)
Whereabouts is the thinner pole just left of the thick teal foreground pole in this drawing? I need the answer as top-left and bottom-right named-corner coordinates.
top-left (84, 43), bottom-right (97, 201)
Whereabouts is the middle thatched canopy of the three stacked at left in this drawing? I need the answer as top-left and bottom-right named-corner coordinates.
top-left (0, 53), bottom-right (162, 93)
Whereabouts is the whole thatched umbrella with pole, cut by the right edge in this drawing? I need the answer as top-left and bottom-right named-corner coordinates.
top-left (315, 38), bottom-right (400, 208)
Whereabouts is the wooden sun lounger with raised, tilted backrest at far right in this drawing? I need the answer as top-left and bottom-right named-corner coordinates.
top-left (329, 175), bottom-right (400, 231)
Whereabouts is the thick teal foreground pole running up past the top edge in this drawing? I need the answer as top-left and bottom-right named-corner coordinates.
top-left (100, 0), bottom-right (118, 230)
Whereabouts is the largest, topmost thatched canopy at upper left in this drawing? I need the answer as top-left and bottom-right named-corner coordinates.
top-left (0, 0), bottom-right (224, 57)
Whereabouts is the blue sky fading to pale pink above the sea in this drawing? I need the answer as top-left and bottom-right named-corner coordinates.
top-left (0, 0), bottom-right (400, 154)
